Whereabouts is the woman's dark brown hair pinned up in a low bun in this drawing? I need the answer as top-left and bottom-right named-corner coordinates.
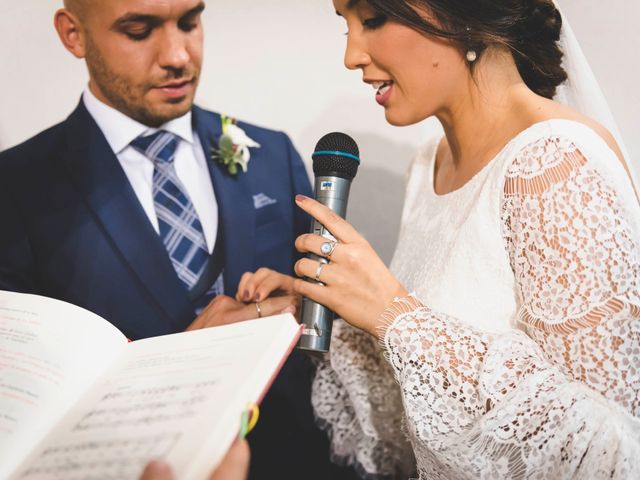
top-left (366, 0), bottom-right (567, 98)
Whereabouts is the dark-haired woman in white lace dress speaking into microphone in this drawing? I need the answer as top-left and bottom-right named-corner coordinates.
top-left (238, 0), bottom-right (640, 478)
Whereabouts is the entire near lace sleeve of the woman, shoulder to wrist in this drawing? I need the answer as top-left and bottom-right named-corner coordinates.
top-left (382, 138), bottom-right (640, 479)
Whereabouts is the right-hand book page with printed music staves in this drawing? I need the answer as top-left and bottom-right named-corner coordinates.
top-left (15, 315), bottom-right (300, 480)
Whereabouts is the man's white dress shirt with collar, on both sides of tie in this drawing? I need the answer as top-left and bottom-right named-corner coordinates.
top-left (82, 87), bottom-right (218, 253)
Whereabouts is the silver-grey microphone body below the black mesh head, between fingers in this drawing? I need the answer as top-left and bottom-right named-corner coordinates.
top-left (298, 176), bottom-right (351, 353)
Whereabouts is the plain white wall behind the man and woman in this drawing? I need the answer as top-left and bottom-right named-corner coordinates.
top-left (0, 0), bottom-right (640, 260)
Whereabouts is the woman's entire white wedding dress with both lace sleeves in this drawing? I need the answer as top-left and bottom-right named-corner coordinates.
top-left (313, 120), bottom-right (640, 479)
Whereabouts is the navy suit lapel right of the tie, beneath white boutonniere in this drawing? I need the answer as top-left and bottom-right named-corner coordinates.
top-left (193, 107), bottom-right (256, 295)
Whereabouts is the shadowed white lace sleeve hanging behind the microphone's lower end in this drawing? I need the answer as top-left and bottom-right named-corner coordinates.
top-left (311, 319), bottom-right (415, 480)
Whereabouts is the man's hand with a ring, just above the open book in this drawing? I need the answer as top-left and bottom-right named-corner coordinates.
top-left (182, 295), bottom-right (298, 331)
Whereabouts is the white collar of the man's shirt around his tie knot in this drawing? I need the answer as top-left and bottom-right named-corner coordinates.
top-left (82, 86), bottom-right (193, 155)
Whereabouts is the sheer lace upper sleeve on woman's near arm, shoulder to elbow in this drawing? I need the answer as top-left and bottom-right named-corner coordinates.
top-left (502, 130), bottom-right (640, 415)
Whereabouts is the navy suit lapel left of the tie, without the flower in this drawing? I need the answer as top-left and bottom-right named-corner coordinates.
top-left (66, 102), bottom-right (193, 330)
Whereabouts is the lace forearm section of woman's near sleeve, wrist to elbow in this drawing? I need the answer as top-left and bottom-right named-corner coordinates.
top-left (383, 300), bottom-right (640, 479)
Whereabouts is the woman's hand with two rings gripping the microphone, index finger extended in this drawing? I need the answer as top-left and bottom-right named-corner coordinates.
top-left (293, 195), bottom-right (408, 336)
